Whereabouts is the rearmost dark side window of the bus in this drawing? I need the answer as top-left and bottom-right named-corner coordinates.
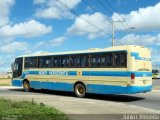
top-left (114, 52), bottom-right (126, 67)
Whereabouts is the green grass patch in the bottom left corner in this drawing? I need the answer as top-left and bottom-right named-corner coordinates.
top-left (0, 99), bottom-right (68, 120)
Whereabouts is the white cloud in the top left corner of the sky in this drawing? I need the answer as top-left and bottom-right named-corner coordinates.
top-left (0, 0), bottom-right (15, 27)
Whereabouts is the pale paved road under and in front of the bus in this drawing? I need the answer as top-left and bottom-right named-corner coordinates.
top-left (0, 87), bottom-right (160, 120)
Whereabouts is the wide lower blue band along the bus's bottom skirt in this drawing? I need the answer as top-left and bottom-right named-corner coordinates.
top-left (12, 80), bottom-right (152, 94)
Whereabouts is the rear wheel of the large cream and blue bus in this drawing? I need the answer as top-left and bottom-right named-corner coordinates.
top-left (74, 83), bottom-right (86, 98)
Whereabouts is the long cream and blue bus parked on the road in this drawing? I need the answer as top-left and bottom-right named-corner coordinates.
top-left (12, 45), bottom-right (152, 97)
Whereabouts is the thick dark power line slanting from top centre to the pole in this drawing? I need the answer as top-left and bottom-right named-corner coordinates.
top-left (56, 0), bottom-right (112, 37)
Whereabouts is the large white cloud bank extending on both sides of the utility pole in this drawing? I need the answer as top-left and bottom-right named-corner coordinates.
top-left (67, 3), bottom-right (160, 39)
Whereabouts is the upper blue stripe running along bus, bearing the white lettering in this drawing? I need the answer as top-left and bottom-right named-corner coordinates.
top-left (21, 71), bottom-right (152, 78)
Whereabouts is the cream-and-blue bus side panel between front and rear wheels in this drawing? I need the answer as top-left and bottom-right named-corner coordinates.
top-left (24, 68), bottom-right (89, 91)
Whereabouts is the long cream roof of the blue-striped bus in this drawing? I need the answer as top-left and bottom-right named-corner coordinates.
top-left (17, 45), bottom-right (148, 58)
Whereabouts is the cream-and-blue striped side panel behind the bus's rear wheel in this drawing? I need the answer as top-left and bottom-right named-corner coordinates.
top-left (86, 68), bottom-right (127, 94)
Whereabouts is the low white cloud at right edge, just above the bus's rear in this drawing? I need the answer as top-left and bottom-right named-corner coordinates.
top-left (117, 34), bottom-right (160, 66)
